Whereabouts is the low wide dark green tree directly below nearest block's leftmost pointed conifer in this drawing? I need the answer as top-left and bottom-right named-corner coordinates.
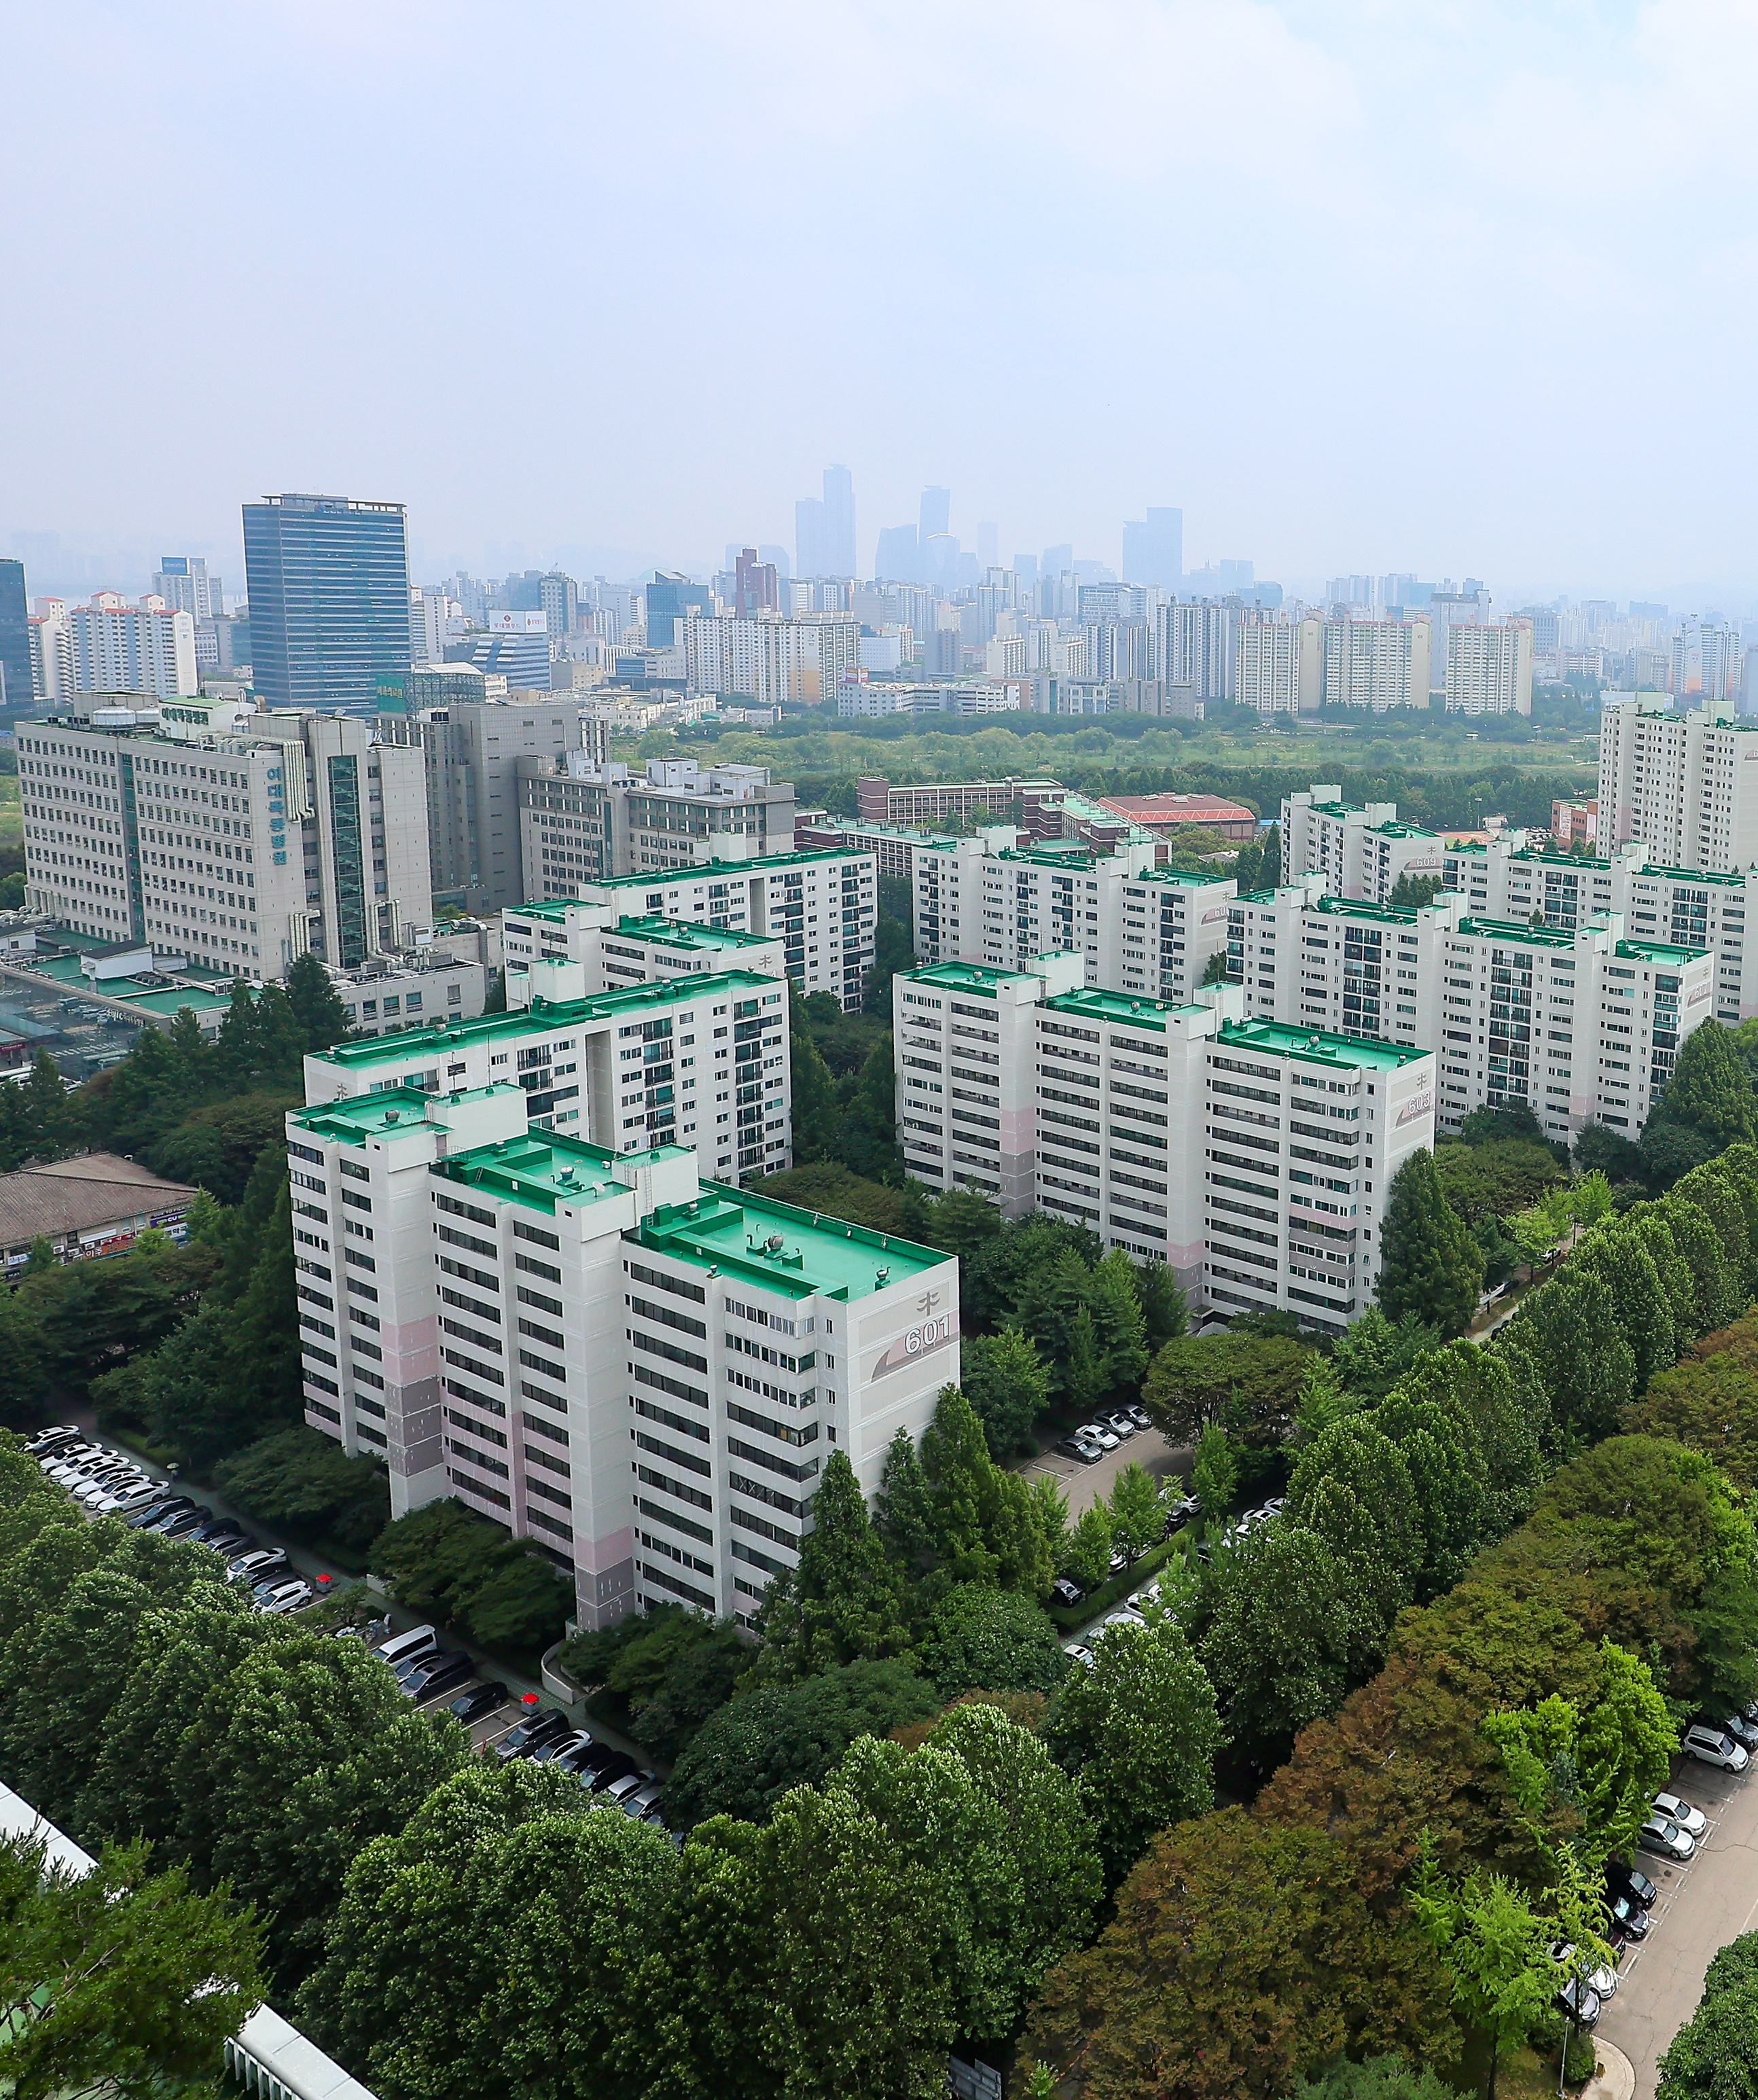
top-left (666, 1661), bottom-right (939, 1827)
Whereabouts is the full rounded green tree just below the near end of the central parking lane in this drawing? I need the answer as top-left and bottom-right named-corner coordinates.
top-left (1044, 1615), bottom-right (1220, 1884)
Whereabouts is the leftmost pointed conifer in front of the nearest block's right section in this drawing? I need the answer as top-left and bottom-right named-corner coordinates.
top-left (762, 1451), bottom-right (910, 1678)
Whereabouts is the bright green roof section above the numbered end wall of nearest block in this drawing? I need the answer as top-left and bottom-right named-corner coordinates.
top-left (624, 1182), bottom-right (950, 1300)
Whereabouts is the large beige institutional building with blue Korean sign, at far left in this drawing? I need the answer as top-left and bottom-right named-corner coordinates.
top-left (19, 693), bottom-right (433, 978)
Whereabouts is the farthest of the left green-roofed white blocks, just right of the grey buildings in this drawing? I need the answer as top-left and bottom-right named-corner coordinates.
top-left (502, 849), bottom-right (878, 1012)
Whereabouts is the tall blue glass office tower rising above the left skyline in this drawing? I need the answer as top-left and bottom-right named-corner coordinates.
top-left (244, 495), bottom-right (410, 714)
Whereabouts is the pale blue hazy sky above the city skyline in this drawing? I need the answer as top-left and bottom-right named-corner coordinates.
top-left (0, 0), bottom-right (1758, 609)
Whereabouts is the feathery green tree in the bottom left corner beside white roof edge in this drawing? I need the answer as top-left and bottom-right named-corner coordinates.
top-left (0, 1838), bottom-right (262, 2100)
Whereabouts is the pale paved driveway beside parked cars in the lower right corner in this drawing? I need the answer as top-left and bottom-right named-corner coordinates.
top-left (1598, 1758), bottom-right (1758, 2100)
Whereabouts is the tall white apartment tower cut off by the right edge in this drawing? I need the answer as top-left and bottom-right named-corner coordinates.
top-left (1598, 693), bottom-right (1758, 874)
